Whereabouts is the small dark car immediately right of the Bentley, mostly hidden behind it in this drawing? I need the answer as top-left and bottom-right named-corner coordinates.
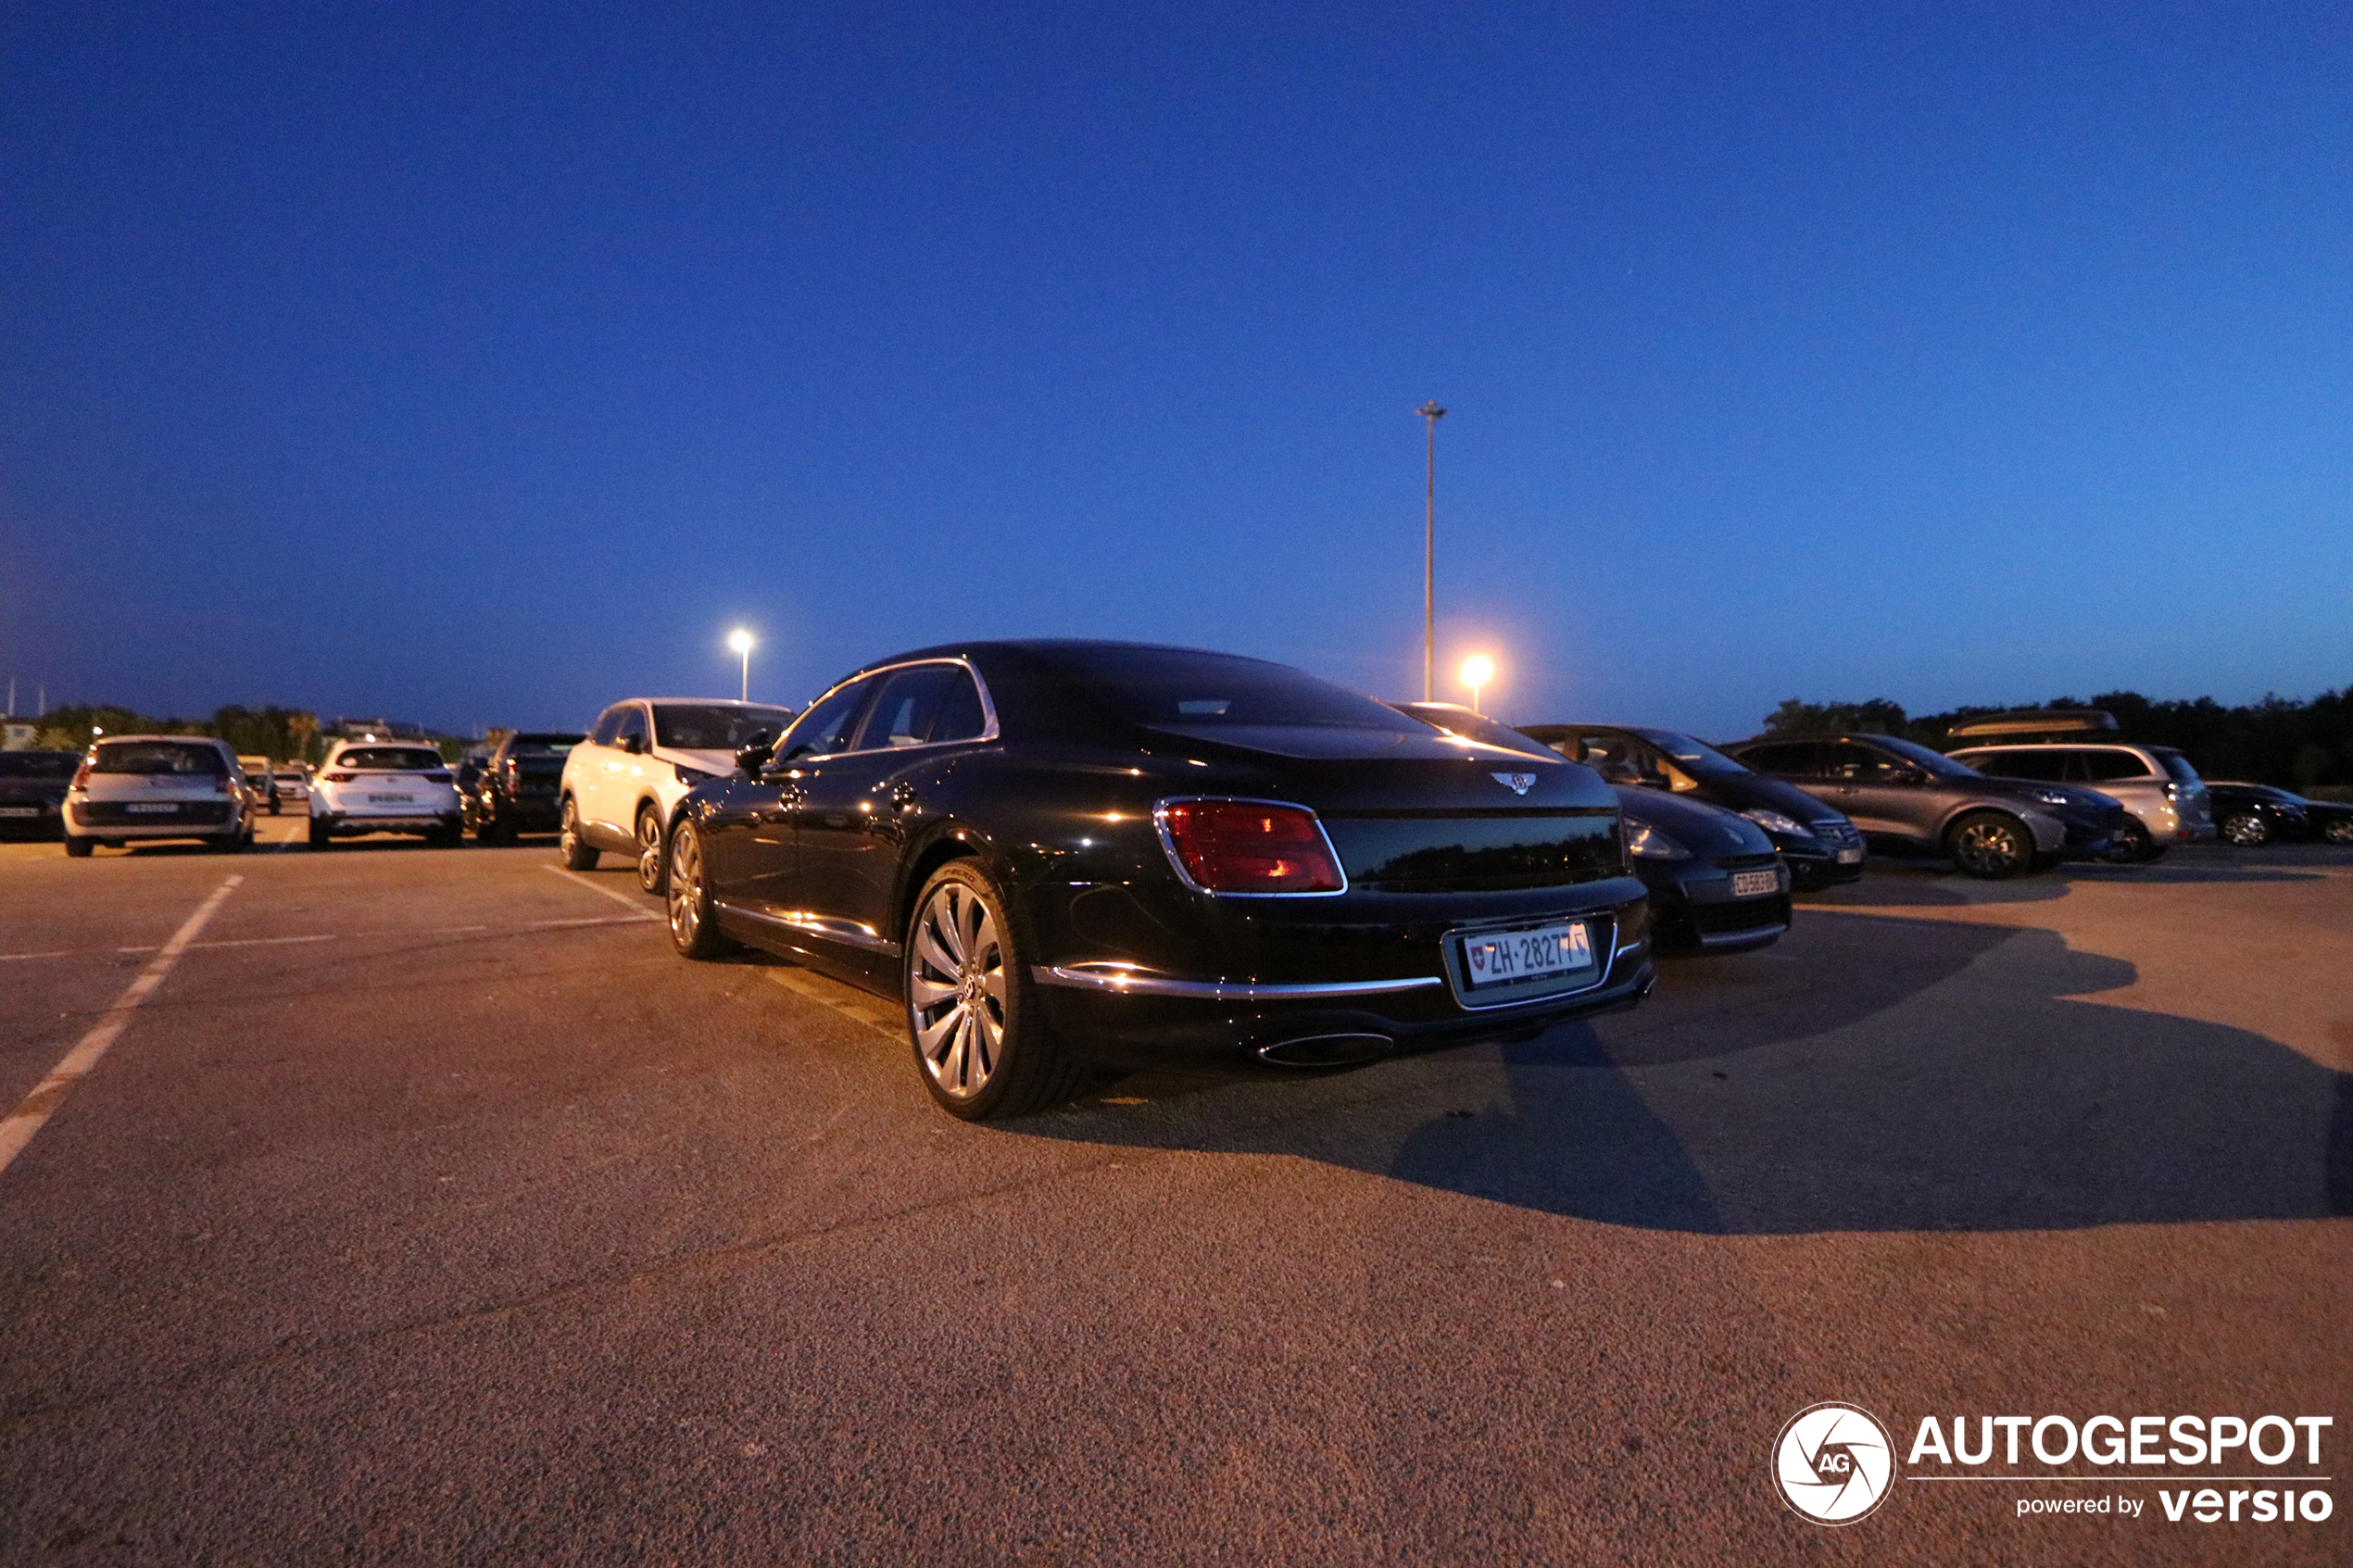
top-left (1395, 703), bottom-right (1779, 952)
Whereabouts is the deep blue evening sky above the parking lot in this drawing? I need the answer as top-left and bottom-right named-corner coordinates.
top-left (0, 0), bottom-right (2353, 735)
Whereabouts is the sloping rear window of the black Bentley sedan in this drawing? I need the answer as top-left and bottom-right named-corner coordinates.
top-left (1045, 646), bottom-right (1428, 735)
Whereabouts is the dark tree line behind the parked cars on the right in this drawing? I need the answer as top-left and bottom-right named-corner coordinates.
top-left (1765, 686), bottom-right (2353, 792)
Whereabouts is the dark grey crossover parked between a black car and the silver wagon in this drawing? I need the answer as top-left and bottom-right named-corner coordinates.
top-left (1718, 735), bottom-right (2130, 877)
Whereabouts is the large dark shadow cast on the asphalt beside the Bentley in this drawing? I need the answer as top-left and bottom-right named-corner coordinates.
top-left (1019, 909), bottom-right (2353, 1235)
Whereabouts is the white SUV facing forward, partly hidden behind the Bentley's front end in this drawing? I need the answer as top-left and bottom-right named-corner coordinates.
top-left (558, 696), bottom-right (796, 894)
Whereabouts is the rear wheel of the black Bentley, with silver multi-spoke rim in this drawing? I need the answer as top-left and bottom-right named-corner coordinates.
top-left (899, 860), bottom-right (1092, 1122)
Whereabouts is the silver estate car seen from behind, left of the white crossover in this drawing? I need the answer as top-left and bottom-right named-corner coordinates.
top-left (61, 735), bottom-right (257, 858)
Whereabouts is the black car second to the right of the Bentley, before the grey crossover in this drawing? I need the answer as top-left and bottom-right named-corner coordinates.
top-left (1525, 724), bottom-right (1866, 888)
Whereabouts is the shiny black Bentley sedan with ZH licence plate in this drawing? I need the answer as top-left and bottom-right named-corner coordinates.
top-left (668, 642), bottom-right (1655, 1119)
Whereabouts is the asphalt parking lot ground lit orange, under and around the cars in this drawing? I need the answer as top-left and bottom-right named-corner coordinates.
top-left (0, 818), bottom-right (2353, 1563)
